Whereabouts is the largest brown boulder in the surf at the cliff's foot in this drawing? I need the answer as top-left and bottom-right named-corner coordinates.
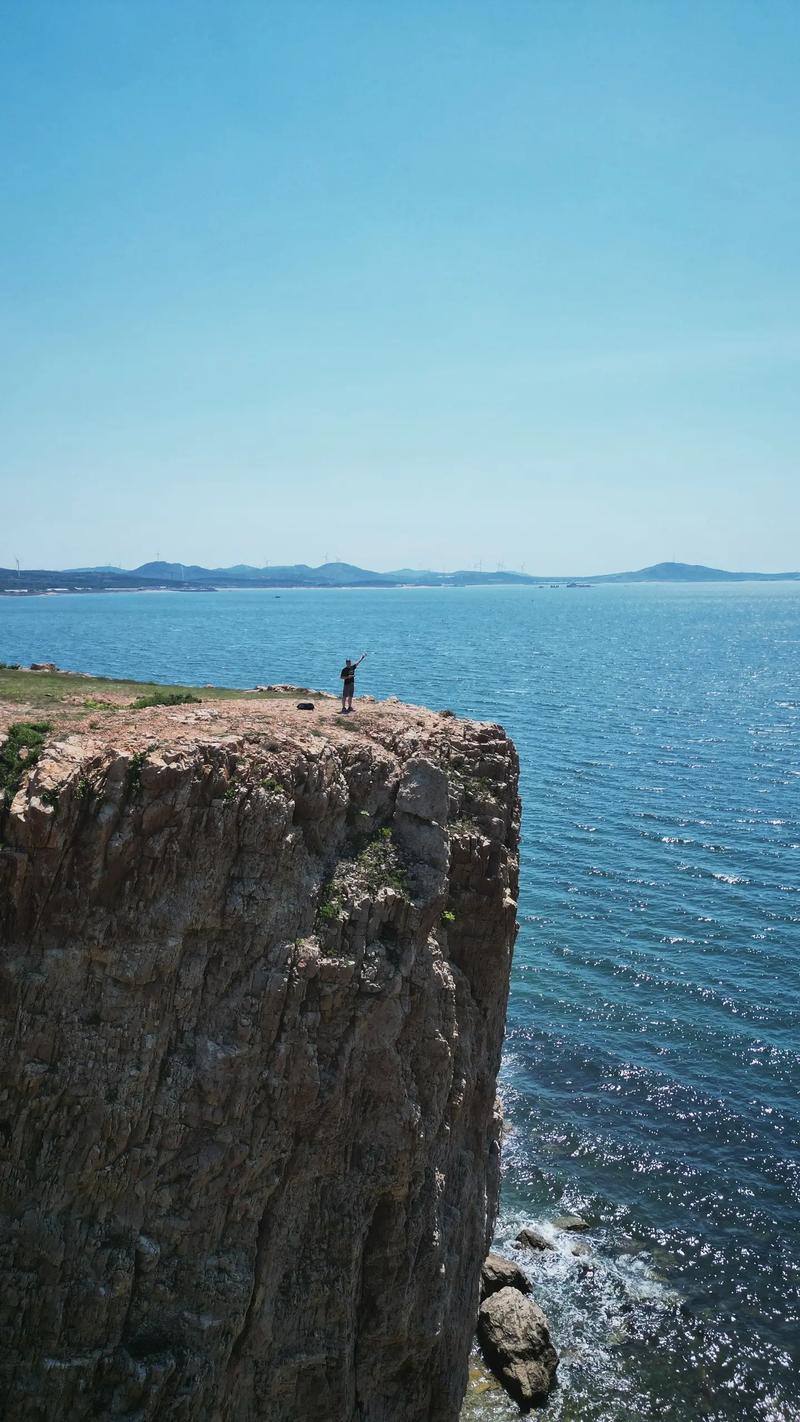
top-left (477, 1288), bottom-right (558, 1412)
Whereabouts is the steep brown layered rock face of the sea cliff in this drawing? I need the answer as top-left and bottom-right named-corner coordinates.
top-left (0, 702), bottom-right (519, 1422)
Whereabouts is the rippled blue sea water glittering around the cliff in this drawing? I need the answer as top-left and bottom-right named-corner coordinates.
top-left (0, 584), bottom-right (800, 1422)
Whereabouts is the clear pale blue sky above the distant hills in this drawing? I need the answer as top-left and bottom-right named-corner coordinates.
top-left (0, 0), bottom-right (800, 572)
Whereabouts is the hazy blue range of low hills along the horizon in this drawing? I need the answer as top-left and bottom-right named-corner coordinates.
top-left (0, 562), bottom-right (800, 593)
